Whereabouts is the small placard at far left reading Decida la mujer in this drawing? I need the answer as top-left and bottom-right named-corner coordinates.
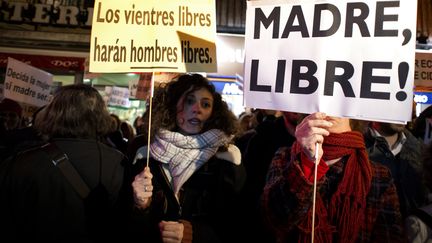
top-left (4, 57), bottom-right (53, 107)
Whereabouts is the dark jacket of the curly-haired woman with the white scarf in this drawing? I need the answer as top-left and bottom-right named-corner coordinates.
top-left (123, 151), bottom-right (245, 243)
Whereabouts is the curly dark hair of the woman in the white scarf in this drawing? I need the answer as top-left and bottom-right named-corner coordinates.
top-left (143, 74), bottom-right (239, 141)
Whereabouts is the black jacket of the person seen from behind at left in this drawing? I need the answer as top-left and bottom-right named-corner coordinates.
top-left (0, 139), bottom-right (124, 242)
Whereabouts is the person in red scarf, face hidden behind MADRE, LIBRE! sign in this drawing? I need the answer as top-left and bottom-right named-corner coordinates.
top-left (261, 112), bottom-right (404, 242)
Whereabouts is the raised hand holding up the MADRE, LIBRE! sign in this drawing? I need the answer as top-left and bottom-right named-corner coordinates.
top-left (295, 112), bottom-right (333, 160)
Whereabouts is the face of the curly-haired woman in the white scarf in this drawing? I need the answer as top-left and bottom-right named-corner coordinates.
top-left (177, 88), bottom-right (213, 135)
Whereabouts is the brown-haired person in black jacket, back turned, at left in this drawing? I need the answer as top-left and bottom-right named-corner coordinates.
top-left (0, 84), bottom-right (124, 242)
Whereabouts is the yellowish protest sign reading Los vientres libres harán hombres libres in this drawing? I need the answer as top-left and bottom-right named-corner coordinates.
top-left (90, 0), bottom-right (217, 73)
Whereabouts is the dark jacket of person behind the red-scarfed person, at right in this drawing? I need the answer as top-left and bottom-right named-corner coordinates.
top-left (364, 129), bottom-right (426, 218)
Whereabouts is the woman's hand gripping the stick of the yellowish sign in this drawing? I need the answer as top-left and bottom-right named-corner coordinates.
top-left (132, 167), bottom-right (153, 209)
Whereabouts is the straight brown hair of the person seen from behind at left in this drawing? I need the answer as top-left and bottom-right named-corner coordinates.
top-left (34, 84), bottom-right (114, 139)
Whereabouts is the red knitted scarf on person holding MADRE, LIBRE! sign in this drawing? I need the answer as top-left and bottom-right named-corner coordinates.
top-left (293, 132), bottom-right (372, 243)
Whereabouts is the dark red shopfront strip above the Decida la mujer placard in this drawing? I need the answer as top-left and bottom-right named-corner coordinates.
top-left (0, 52), bottom-right (85, 72)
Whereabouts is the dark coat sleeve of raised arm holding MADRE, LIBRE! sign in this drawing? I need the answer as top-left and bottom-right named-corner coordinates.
top-left (261, 148), bottom-right (322, 237)
